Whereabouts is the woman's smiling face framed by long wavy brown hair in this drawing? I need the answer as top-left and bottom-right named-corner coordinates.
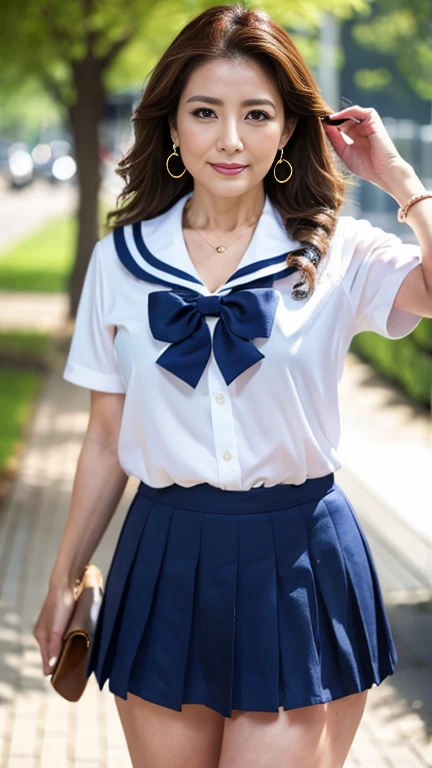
top-left (170, 59), bottom-right (297, 197)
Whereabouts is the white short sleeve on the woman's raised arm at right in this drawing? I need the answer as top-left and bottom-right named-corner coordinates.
top-left (343, 216), bottom-right (422, 339)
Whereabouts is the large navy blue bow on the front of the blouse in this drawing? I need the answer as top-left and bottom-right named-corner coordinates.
top-left (148, 280), bottom-right (278, 388)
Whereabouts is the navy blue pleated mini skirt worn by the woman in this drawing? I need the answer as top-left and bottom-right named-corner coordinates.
top-left (87, 473), bottom-right (397, 717)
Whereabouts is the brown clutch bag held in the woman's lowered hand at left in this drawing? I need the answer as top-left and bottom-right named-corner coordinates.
top-left (51, 563), bottom-right (103, 701)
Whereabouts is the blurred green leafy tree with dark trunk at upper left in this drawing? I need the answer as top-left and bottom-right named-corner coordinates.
top-left (0, 0), bottom-right (369, 317)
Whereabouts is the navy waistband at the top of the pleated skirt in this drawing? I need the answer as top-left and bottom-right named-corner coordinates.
top-left (137, 472), bottom-right (334, 513)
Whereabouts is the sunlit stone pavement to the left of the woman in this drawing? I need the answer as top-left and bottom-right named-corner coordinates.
top-left (0, 344), bottom-right (136, 768)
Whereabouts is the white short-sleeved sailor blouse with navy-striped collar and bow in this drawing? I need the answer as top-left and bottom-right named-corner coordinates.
top-left (63, 193), bottom-right (421, 490)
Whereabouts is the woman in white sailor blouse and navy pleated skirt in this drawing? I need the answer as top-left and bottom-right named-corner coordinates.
top-left (35, 5), bottom-right (432, 768)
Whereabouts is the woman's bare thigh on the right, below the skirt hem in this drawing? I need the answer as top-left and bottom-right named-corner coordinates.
top-left (218, 691), bottom-right (368, 768)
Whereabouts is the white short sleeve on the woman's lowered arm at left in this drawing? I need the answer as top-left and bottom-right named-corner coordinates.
top-left (63, 243), bottom-right (126, 392)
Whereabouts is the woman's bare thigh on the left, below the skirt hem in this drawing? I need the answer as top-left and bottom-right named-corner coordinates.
top-left (114, 693), bottom-right (225, 768)
